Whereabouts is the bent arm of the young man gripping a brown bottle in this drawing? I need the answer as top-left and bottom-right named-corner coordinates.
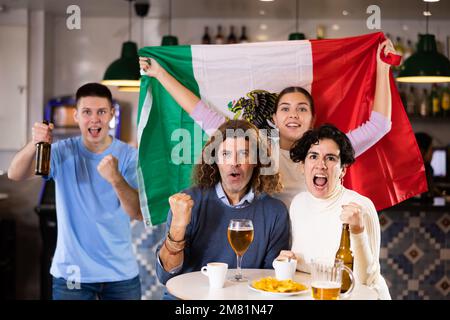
top-left (8, 122), bottom-right (53, 181)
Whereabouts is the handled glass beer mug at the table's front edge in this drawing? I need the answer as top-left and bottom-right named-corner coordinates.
top-left (311, 259), bottom-right (355, 300)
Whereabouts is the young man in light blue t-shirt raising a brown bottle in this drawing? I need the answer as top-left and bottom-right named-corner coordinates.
top-left (8, 83), bottom-right (142, 300)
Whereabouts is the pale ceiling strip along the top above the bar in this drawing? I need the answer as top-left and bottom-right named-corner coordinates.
top-left (0, 0), bottom-right (450, 20)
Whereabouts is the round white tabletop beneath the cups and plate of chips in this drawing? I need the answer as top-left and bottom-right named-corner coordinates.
top-left (166, 269), bottom-right (378, 300)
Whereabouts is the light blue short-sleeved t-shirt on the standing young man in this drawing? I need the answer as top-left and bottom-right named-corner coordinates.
top-left (49, 136), bottom-right (139, 283)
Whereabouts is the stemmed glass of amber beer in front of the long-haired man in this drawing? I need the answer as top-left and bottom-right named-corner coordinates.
top-left (227, 219), bottom-right (253, 281)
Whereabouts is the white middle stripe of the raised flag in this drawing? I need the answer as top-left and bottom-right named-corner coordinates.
top-left (191, 40), bottom-right (313, 117)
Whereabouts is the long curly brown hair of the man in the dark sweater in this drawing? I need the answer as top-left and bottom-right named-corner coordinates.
top-left (192, 120), bottom-right (282, 194)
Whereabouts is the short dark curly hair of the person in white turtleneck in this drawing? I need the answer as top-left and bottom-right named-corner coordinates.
top-left (290, 124), bottom-right (355, 167)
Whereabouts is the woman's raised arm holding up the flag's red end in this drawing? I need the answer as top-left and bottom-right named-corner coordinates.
top-left (347, 40), bottom-right (397, 157)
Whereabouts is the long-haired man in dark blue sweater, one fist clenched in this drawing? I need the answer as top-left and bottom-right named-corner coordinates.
top-left (156, 120), bottom-right (289, 298)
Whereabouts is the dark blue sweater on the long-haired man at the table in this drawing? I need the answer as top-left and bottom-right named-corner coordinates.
top-left (156, 187), bottom-right (289, 284)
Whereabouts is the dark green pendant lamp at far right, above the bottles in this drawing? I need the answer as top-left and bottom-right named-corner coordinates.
top-left (397, 2), bottom-right (450, 83)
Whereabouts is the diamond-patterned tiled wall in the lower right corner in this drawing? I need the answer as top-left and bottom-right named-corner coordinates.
top-left (380, 210), bottom-right (450, 300)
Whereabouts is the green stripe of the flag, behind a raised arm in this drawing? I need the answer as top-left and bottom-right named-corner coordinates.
top-left (138, 46), bottom-right (200, 225)
